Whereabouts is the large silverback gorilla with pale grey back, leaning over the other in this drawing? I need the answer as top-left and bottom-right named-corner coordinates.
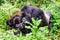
top-left (21, 5), bottom-right (52, 30)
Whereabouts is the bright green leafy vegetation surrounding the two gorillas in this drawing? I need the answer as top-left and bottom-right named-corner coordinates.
top-left (0, 0), bottom-right (60, 40)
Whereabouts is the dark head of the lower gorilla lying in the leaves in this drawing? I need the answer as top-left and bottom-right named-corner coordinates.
top-left (6, 15), bottom-right (22, 29)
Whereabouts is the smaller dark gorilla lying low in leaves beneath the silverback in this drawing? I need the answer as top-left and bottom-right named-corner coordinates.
top-left (6, 15), bottom-right (31, 35)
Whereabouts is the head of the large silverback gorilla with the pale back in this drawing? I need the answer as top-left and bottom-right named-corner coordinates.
top-left (21, 6), bottom-right (32, 17)
